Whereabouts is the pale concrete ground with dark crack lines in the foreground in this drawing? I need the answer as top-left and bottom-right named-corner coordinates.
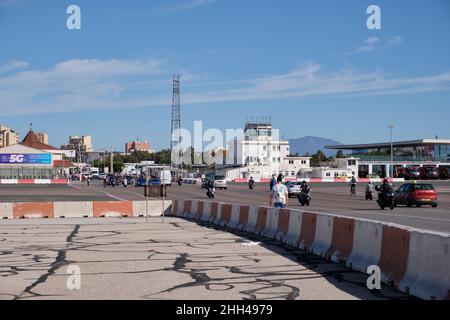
top-left (0, 217), bottom-right (411, 300)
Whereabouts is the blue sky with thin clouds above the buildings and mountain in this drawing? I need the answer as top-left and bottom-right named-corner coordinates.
top-left (0, 0), bottom-right (450, 149)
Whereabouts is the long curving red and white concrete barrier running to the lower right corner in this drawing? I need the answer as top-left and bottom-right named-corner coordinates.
top-left (172, 200), bottom-right (450, 300)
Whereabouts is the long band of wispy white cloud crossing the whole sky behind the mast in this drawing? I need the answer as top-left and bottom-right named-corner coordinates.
top-left (0, 59), bottom-right (450, 115)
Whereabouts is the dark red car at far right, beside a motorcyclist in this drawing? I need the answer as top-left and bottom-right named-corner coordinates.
top-left (394, 183), bottom-right (439, 208)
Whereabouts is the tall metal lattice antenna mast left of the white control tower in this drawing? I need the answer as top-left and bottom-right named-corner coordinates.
top-left (170, 75), bottom-right (181, 167)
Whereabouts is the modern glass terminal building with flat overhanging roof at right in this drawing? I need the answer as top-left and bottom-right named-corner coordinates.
top-left (326, 139), bottom-right (450, 178)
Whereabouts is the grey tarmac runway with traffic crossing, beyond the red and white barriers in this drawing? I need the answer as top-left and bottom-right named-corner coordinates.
top-left (0, 181), bottom-right (450, 233)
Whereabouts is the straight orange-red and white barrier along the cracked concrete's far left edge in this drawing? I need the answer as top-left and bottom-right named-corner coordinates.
top-left (0, 200), bottom-right (172, 219)
